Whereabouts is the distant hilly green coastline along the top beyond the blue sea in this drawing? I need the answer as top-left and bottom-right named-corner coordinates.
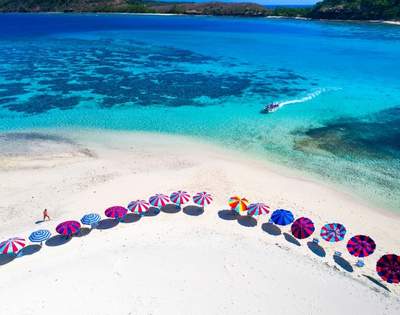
top-left (0, 0), bottom-right (400, 21)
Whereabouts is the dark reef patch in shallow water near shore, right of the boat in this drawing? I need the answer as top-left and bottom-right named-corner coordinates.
top-left (295, 106), bottom-right (400, 159)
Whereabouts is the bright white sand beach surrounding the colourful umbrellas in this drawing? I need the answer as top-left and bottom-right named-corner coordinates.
top-left (0, 131), bottom-right (400, 315)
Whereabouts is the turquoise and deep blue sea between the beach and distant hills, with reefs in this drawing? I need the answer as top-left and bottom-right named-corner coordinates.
top-left (0, 14), bottom-right (400, 211)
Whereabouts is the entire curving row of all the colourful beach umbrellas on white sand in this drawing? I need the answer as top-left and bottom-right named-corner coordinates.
top-left (0, 190), bottom-right (400, 283)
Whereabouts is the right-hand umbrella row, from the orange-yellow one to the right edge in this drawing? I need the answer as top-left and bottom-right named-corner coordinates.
top-left (228, 196), bottom-right (400, 283)
